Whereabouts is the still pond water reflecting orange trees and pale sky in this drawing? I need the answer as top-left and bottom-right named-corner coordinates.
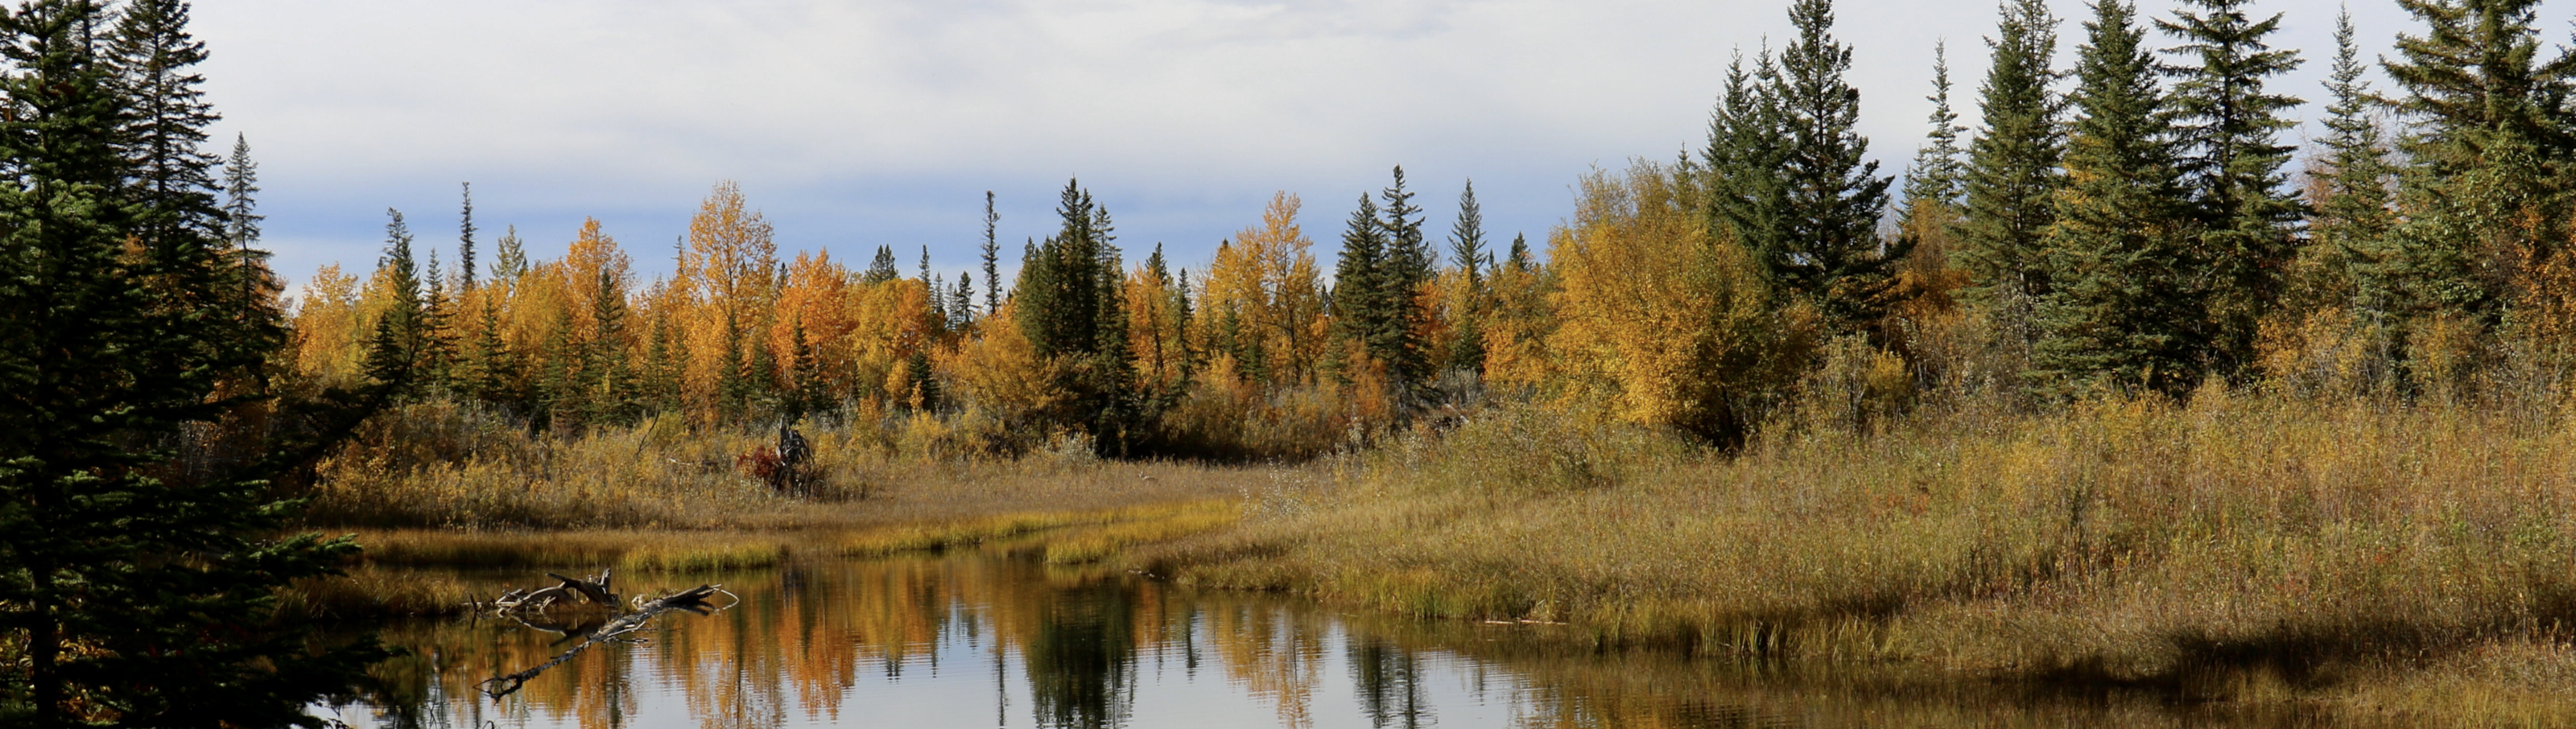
top-left (317, 551), bottom-right (2310, 729)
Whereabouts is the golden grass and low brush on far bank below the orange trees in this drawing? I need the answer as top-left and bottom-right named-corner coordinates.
top-left (307, 402), bottom-right (1278, 530)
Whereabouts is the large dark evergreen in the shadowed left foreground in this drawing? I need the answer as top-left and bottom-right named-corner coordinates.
top-left (0, 0), bottom-right (382, 727)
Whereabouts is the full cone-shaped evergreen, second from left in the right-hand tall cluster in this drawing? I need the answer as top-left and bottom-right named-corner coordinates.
top-left (2033, 0), bottom-right (2205, 394)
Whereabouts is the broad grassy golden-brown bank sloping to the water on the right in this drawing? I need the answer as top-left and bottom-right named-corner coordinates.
top-left (1131, 392), bottom-right (2576, 715)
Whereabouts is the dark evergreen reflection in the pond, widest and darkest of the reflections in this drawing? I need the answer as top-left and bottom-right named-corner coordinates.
top-left (1022, 583), bottom-right (1136, 729)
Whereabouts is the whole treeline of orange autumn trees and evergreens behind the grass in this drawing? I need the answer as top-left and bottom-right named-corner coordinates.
top-left (312, 0), bottom-right (2576, 459)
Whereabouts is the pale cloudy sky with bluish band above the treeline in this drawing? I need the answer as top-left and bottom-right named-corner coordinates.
top-left (191, 0), bottom-right (2576, 289)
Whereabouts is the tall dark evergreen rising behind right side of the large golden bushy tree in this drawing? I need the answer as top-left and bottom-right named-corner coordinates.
top-left (1754, 0), bottom-right (1911, 330)
